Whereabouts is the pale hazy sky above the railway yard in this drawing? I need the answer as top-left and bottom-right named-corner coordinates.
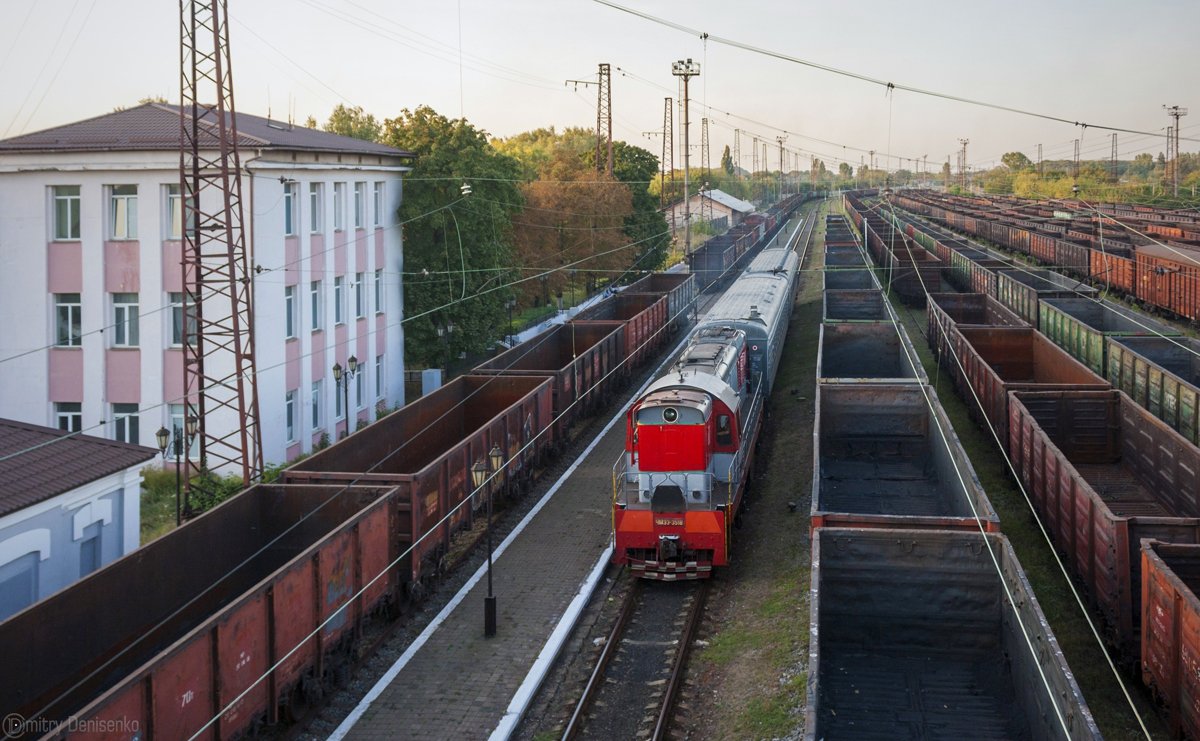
top-left (0, 0), bottom-right (1200, 169)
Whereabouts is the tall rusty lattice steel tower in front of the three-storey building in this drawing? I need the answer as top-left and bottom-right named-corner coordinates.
top-left (179, 0), bottom-right (263, 489)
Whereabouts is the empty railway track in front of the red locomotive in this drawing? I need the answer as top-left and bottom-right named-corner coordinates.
top-left (562, 580), bottom-right (709, 741)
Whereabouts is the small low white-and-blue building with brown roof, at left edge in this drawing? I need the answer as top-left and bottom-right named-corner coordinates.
top-left (0, 420), bottom-right (158, 621)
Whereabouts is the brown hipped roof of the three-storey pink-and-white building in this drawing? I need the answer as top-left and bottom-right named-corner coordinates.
top-left (0, 103), bottom-right (413, 157)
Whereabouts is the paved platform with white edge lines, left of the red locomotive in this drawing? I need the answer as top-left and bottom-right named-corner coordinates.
top-left (331, 381), bottom-right (624, 740)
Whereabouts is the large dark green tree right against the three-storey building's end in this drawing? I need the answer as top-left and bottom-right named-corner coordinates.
top-left (383, 106), bottom-right (523, 365)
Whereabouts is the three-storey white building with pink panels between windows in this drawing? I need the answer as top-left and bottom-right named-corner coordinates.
top-left (0, 103), bottom-right (412, 463)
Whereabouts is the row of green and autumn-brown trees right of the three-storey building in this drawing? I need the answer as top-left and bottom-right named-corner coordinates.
top-left (306, 104), bottom-right (671, 367)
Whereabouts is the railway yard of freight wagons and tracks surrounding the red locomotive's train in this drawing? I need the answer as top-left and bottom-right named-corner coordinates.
top-left (0, 192), bottom-right (1200, 739)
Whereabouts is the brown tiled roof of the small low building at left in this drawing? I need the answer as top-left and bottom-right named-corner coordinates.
top-left (0, 420), bottom-right (158, 517)
